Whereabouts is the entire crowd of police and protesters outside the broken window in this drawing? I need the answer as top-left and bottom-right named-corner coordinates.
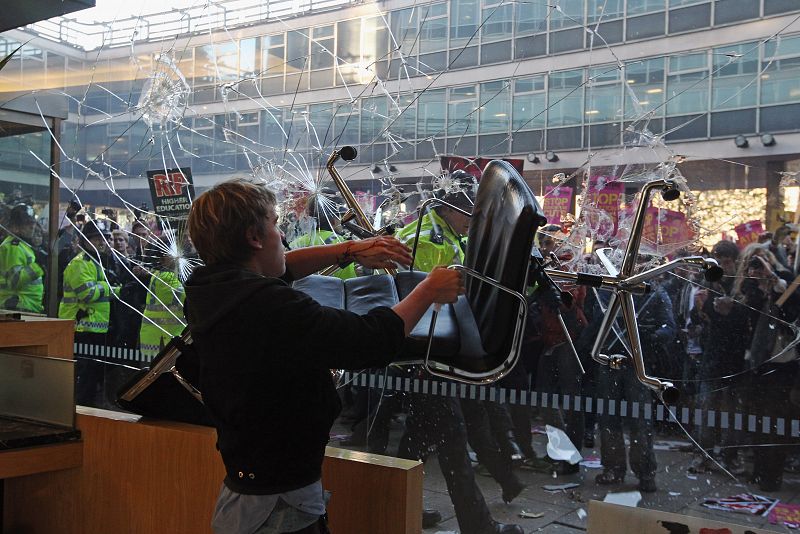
top-left (0, 186), bottom-right (800, 532)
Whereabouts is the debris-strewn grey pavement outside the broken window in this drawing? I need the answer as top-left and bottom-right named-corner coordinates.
top-left (331, 421), bottom-right (800, 534)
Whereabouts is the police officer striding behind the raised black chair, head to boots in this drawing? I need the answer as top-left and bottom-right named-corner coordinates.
top-left (396, 171), bottom-right (524, 534)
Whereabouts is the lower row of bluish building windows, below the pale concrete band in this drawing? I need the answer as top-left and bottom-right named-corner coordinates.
top-left (39, 36), bottom-right (800, 173)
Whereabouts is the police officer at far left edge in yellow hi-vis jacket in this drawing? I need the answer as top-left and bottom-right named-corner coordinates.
top-left (0, 204), bottom-right (44, 313)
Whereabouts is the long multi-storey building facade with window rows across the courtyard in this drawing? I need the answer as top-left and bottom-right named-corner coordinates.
top-left (0, 0), bottom-right (800, 216)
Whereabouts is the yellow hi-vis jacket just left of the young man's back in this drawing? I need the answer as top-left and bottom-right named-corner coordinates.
top-left (139, 271), bottom-right (185, 361)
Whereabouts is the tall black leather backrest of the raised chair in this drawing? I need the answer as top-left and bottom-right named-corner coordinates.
top-left (464, 160), bottom-right (546, 364)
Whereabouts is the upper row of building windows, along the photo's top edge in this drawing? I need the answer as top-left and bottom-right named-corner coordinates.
top-left (0, 0), bottom-right (798, 108)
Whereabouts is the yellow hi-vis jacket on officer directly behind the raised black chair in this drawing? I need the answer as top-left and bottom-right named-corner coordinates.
top-left (395, 210), bottom-right (464, 272)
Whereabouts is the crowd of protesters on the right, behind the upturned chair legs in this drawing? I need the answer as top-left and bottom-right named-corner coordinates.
top-left (343, 220), bottom-right (800, 528)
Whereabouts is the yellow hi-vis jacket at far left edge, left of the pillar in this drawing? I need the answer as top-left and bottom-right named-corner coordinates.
top-left (0, 236), bottom-right (44, 313)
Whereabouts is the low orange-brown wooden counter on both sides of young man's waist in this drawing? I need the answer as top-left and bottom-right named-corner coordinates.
top-left (4, 408), bottom-right (423, 534)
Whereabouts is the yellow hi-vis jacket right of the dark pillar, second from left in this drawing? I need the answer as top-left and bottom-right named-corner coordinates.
top-left (58, 252), bottom-right (119, 334)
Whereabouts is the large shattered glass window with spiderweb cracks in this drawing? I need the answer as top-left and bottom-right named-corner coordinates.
top-left (0, 0), bottom-right (800, 534)
